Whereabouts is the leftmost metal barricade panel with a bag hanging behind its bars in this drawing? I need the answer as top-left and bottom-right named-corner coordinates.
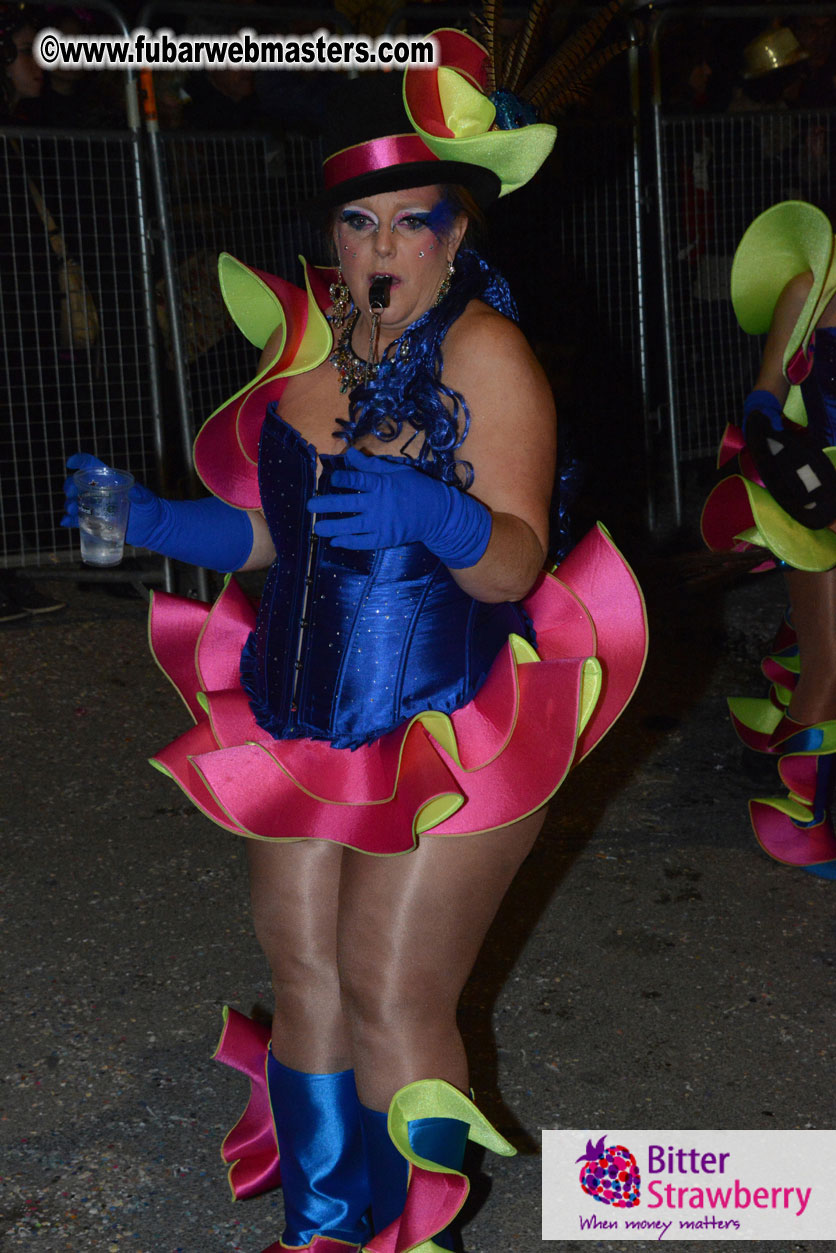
top-left (0, 119), bottom-right (160, 566)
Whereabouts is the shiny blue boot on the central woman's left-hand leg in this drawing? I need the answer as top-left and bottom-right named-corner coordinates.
top-left (264, 1051), bottom-right (371, 1253)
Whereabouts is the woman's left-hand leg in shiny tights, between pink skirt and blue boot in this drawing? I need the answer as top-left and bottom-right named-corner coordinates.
top-left (247, 840), bottom-right (351, 1074)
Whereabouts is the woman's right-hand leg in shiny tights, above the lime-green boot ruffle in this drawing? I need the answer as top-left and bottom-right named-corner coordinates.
top-left (338, 809), bottom-right (545, 1110)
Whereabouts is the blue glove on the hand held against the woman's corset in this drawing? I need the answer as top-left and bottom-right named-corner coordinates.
top-left (307, 449), bottom-right (491, 570)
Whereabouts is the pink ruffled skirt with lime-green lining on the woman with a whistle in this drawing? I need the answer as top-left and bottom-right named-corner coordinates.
top-left (150, 526), bottom-right (647, 853)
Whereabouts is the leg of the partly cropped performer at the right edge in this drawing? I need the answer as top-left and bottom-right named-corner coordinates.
top-left (786, 569), bottom-right (836, 724)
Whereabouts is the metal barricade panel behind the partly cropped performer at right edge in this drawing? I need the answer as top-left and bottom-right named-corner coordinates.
top-left (659, 110), bottom-right (836, 461)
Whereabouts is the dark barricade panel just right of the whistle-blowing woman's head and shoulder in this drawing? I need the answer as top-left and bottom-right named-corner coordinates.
top-left (503, 111), bottom-right (648, 525)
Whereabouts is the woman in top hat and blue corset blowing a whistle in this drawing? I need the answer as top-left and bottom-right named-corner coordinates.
top-left (65, 12), bottom-right (645, 1253)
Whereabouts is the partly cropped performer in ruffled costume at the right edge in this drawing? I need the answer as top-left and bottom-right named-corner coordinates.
top-left (702, 200), bottom-right (836, 878)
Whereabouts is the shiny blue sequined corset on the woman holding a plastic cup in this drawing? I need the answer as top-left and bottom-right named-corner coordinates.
top-left (241, 403), bottom-right (534, 748)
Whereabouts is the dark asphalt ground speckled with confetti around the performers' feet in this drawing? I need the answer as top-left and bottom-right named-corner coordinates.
top-left (0, 558), bottom-right (836, 1253)
